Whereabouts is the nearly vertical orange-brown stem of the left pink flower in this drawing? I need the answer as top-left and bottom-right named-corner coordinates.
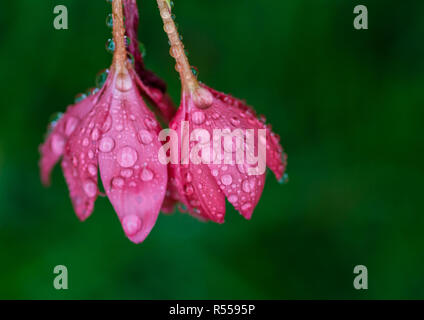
top-left (112, 0), bottom-right (127, 73)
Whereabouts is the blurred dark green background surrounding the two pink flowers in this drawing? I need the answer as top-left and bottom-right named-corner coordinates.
top-left (0, 0), bottom-right (424, 299)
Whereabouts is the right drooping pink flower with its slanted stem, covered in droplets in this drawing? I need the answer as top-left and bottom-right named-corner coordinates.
top-left (157, 0), bottom-right (286, 223)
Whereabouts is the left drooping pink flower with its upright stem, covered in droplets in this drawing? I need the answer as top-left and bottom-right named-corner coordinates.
top-left (40, 0), bottom-right (167, 243)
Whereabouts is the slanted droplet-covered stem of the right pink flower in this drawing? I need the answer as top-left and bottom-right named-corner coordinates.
top-left (157, 0), bottom-right (199, 93)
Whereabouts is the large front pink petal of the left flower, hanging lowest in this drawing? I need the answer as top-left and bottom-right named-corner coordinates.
top-left (99, 70), bottom-right (167, 243)
